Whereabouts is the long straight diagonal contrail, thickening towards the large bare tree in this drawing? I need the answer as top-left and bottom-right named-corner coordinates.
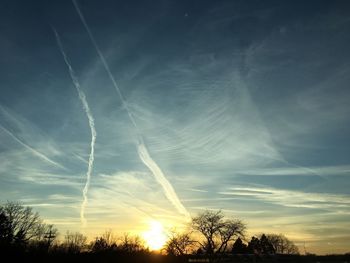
top-left (72, 0), bottom-right (191, 219)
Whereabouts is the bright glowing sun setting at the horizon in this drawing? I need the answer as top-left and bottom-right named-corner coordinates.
top-left (143, 220), bottom-right (167, 250)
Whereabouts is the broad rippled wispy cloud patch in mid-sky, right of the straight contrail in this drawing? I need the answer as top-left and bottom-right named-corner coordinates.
top-left (130, 72), bottom-right (282, 171)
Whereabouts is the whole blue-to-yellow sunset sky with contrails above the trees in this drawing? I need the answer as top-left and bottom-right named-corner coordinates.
top-left (0, 0), bottom-right (350, 254)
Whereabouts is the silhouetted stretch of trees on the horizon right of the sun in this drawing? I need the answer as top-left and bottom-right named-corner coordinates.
top-left (164, 210), bottom-right (299, 257)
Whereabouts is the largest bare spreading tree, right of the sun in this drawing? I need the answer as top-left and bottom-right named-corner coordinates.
top-left (192, 210), bottom-right (246, 254)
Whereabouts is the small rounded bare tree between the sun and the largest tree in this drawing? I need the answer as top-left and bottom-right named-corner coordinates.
top-left (164, 231), bottom-right (195, 256)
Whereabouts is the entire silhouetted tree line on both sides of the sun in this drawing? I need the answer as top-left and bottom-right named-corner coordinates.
top-left (0, 202), bottom-right (299, 258)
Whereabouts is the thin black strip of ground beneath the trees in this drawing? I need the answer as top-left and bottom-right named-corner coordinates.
top-left (4, 252), bottom-right (350, 263)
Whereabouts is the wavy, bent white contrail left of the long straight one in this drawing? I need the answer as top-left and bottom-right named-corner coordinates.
top-left (52, 28), bottom-right (97, 227)
